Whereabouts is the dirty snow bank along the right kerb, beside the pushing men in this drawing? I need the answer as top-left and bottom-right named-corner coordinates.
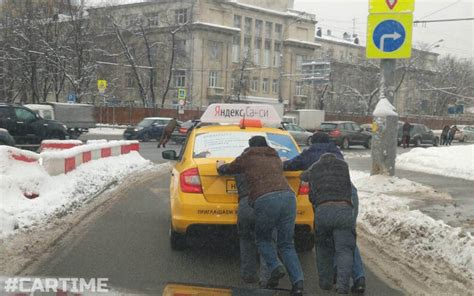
top-left (351, 171), bottom-right (474, 280)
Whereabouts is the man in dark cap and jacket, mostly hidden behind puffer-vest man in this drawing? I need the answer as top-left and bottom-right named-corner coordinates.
top-left (283, 133), bottom-right (365, 293)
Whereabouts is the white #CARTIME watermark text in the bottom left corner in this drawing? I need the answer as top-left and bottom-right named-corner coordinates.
top-left (3, 277), bottom-right (109, 293)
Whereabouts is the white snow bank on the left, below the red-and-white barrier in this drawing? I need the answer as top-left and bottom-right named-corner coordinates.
top-left (0, 151), bottom-right (152, 238)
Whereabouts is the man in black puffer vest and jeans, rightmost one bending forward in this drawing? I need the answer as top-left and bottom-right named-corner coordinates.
top-left (301, 153), bottom-right (356, 294)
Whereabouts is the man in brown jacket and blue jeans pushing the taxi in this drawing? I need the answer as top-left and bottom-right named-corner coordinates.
top-left (217, 136), bottom-right (303, 296)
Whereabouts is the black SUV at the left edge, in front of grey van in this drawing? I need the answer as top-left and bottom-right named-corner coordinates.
top-left (0, 104), bottom-right (68, 147)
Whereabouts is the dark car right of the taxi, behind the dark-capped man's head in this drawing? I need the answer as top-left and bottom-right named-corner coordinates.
top-left (318, 121), bottom-right (372, 149)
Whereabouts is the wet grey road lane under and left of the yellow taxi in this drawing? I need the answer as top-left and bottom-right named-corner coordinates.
top-left (25, 142), bottom-right (401, 295)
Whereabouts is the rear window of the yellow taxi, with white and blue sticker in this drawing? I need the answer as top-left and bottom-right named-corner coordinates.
top-left (193, 132), bottom-right (299, 159)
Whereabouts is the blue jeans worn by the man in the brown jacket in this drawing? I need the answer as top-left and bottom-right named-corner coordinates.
top-left (255, 191), bottom-right (303, 284)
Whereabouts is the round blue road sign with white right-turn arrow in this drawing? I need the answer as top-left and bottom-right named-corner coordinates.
top-left (372, 20), bottom-right (406, 52)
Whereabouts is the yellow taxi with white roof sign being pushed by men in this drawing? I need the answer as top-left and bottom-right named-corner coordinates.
top-left (162, 104), bottom-right (314, 251)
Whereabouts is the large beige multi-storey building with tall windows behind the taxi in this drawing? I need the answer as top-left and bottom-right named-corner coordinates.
top-left (89, 0), bottom-right (319, 107)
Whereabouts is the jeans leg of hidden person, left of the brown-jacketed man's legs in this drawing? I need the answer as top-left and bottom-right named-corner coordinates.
top-left (237, 197), bottom-right (270, 283)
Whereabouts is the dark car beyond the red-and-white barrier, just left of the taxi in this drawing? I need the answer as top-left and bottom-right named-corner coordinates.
top-left (123, 117), bottom-right (172, 142)
